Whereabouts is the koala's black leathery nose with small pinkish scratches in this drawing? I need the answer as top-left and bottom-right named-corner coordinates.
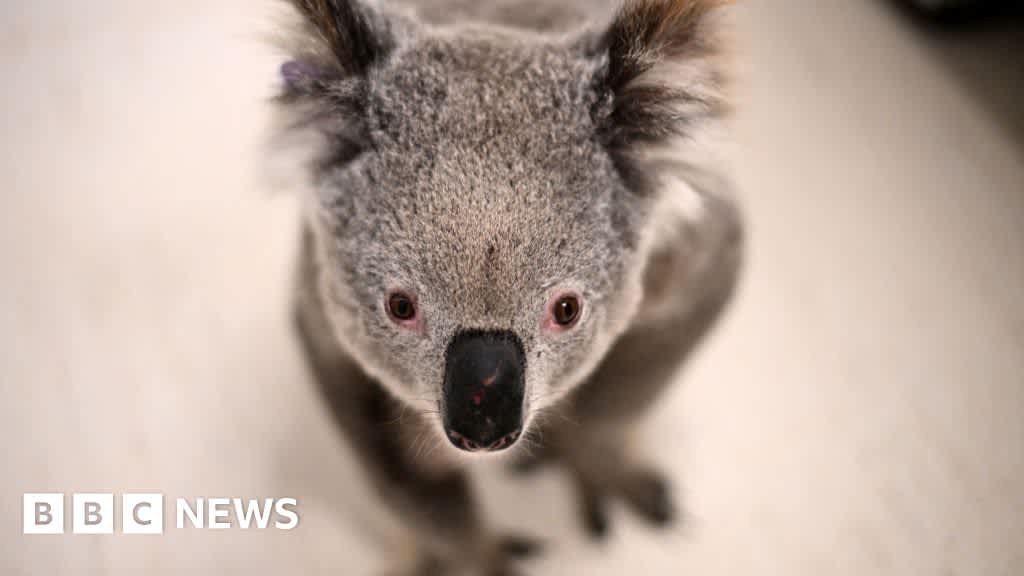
top-left (441, 332), bottom-right (526, 451)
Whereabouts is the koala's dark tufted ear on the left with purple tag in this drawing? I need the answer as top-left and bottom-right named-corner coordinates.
top-left (281, 0), bottom-right (394, 95)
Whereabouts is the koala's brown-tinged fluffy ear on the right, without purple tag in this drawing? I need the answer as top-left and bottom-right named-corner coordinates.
top-left (595, 0), bottom-right (728, 189)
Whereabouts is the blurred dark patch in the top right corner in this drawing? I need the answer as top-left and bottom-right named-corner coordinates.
top-left (885, 0), bottom-right (1024, 155)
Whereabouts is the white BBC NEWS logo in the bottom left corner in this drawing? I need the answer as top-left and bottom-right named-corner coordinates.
top-left (24, 493), bottom-right (299, 534)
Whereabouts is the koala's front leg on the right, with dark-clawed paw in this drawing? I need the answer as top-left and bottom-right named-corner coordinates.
top-left (545, 194), bottom-right (741, 536)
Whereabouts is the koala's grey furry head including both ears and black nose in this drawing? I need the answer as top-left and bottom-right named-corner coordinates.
top-left (281, 0), bottom-right (720, 451)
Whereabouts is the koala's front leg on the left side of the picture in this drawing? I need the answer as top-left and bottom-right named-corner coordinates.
top-left (294, 231), bottom-right (535, 575)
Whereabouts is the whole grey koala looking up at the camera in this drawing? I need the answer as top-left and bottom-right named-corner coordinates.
top-left (276, 0), bottom-right (742, 575)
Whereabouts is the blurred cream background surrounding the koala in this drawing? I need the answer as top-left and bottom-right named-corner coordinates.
top-left (0, 0), bottom-right (1024, 576)
